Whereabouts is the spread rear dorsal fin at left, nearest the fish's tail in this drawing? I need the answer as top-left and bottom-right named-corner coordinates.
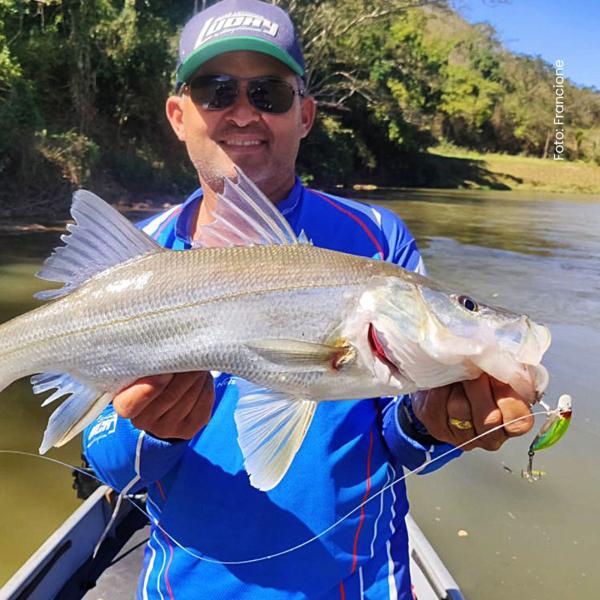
top-left (35, 190), bottom-right (162, 300)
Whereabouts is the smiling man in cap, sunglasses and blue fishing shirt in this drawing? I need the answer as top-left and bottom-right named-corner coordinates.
top-left (84, 0), bottom-right (532, 600)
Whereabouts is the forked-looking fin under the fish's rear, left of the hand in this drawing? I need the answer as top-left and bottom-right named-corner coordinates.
top-left (31, 373), bottom-right (114, 454)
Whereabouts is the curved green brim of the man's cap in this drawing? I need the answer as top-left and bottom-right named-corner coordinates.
top-left (177, 36), bottom-right (304, 83)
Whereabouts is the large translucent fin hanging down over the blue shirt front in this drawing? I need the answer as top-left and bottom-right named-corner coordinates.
top-left (234, 390), bottom-right (317, 492)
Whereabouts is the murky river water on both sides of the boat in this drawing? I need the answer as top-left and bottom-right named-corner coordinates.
top-left (0, 190), bottom-right (600, 600)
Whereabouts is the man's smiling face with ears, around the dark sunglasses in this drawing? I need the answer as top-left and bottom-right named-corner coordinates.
top-left (167, 51), bottom-right (315, 201)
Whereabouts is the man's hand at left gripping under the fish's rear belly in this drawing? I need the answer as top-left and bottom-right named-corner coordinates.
top-left (113, 372), bottom-right (215, 440)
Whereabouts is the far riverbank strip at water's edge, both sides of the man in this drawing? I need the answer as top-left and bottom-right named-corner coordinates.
top-left (0, 146), bottom-right (600, 223)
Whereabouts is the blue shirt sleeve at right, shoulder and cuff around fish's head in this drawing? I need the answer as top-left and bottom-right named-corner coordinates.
top-left (375, 207), bottom-right (462, 474)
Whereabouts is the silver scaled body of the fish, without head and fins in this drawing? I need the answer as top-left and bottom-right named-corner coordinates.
top-left (0, 245), bottom-right (404, 392)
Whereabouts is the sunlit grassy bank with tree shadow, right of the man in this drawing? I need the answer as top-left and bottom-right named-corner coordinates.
top-left (423, 147), bottom-right (600, 194)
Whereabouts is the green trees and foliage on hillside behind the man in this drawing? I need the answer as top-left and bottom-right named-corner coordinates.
top-left (0, 0), bottom-right (600, 214)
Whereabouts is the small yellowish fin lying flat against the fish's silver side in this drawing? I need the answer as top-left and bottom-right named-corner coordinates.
top-left (245, 339), bottom-right (356, 370)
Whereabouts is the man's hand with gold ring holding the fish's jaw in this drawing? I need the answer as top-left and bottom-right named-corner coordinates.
top-left (412, 374), bottom-right (533, 450)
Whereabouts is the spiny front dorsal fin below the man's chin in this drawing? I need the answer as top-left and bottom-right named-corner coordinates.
top-left (195, 167), bottom-right (308, 246)
